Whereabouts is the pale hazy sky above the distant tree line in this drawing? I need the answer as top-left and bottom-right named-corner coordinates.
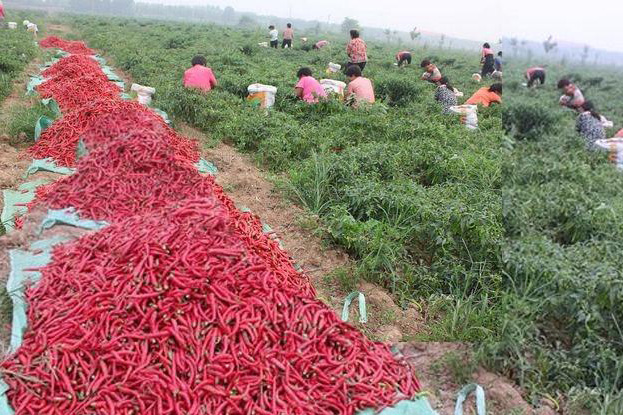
top-left (140, 0), bottom-right (623, 51)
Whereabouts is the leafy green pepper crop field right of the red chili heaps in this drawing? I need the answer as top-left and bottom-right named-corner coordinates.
top-left (0, 7), bottom-right (623, 414)
